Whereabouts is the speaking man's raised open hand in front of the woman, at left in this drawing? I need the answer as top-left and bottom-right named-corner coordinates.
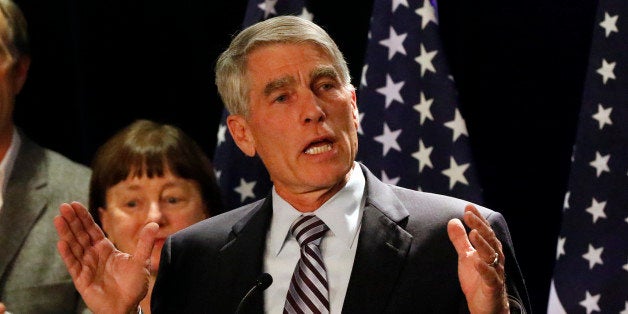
top-left (54, 202), bottom-right (159, 314)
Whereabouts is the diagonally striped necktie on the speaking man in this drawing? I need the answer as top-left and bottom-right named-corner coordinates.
top-left (283, 215), bottom-right (329, 314)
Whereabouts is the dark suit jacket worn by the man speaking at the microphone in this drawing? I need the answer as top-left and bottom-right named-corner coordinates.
top-left (152, 165), bottom-right (530, 313)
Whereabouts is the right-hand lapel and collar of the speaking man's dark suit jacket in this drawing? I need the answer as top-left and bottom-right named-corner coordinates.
top-left (342, 167), bottom-right (412, 313)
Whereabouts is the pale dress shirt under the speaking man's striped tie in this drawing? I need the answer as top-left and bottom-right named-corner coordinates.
top-left (264, 163), bottom-right (365, 314)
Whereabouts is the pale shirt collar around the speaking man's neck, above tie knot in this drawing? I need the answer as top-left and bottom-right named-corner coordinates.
top-left (269, 162), bottom-right (366, 255)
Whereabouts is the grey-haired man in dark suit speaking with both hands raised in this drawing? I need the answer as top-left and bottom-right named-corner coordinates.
top-left (55, 16), bottom-right (529, 313)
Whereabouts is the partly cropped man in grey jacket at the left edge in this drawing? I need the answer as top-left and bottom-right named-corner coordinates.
top-left (0, 0), bottom-right (91, 313)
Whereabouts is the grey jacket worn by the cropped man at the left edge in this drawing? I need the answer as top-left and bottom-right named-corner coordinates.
top-left (0, 134), bottom-right (91, 314)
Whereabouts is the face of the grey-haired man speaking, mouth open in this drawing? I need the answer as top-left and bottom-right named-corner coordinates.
top-left (232, 44), bottom-right (358, 202)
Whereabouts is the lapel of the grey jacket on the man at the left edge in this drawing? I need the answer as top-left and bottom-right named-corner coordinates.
top-left (0, 137), bottom-right (47, 278)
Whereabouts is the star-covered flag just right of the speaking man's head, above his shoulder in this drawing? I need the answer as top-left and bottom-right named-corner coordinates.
top-left (357, 0), bottom-right (482, 204)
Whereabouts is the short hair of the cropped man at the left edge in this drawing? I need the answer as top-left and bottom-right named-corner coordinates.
top-left (0, 0), bottom-right (30, 59)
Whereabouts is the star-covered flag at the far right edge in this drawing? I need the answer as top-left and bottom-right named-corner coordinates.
top-left (548, 0), bottom-right (628, 314)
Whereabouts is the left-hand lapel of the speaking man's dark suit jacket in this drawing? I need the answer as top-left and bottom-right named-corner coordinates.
top-left (220, 197), bottom-right (272, 313)
